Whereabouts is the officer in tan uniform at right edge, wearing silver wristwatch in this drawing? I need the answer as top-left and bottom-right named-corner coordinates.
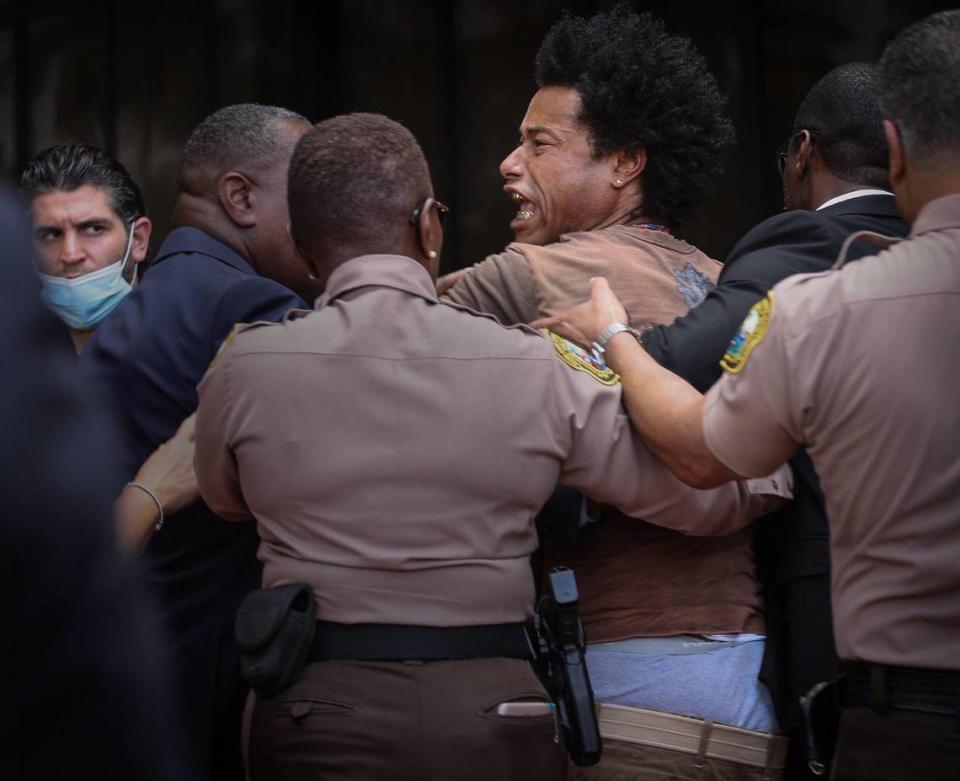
top-left (544, 11), bottom-right (960, 781)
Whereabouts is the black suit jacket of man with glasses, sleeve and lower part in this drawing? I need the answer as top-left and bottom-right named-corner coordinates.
top-left (643, 195), bottom-right (907, 730)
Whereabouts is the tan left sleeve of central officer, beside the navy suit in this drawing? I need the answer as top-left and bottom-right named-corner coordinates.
top-left (193, 345), bottom-right (254, 521)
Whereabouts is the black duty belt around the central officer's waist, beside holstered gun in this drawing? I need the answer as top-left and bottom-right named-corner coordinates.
top-left (307, 621), bottom-right (532, 662)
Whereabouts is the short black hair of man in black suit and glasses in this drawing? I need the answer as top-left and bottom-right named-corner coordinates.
top-left (793, 62), bottom-right (890, 187)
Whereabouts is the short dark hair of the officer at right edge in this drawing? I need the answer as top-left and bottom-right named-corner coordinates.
top-left (880, 11), bottom-right (960, 162)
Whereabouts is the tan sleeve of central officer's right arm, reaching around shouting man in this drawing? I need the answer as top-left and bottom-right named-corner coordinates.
top-left (554, 348), bottom-right (792, 535)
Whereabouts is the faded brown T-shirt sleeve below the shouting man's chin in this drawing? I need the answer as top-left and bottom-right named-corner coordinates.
top-left (444, 248), bottom-right (540, 325)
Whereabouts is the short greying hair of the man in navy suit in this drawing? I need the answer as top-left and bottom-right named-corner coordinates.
top-left (177, 103), bottom-right (309, 192)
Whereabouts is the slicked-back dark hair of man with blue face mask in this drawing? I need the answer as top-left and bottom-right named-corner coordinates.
top-left (20, 144), bottom-right (147, 229)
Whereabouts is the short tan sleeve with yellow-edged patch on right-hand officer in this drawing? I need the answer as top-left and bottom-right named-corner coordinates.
top-left (703, 287), bottom-right (803, 477)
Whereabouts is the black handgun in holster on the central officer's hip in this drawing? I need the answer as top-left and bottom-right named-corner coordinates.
top-left (534, 567), bottom-right (602, 767)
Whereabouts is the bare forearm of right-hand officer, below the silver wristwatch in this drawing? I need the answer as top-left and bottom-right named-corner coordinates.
top-left (605, 332), bottom-right (739, 488)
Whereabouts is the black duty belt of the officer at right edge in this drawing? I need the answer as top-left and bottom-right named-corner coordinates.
top-left (843, 662), bottom-right (960, 716)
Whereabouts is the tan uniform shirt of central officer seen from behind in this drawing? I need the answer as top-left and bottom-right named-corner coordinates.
top-left (196, 255), bottom-right (783, 626)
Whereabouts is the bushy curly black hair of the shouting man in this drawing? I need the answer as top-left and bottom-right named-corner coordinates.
top-left (536, 4), bottom-right (733, 225)
